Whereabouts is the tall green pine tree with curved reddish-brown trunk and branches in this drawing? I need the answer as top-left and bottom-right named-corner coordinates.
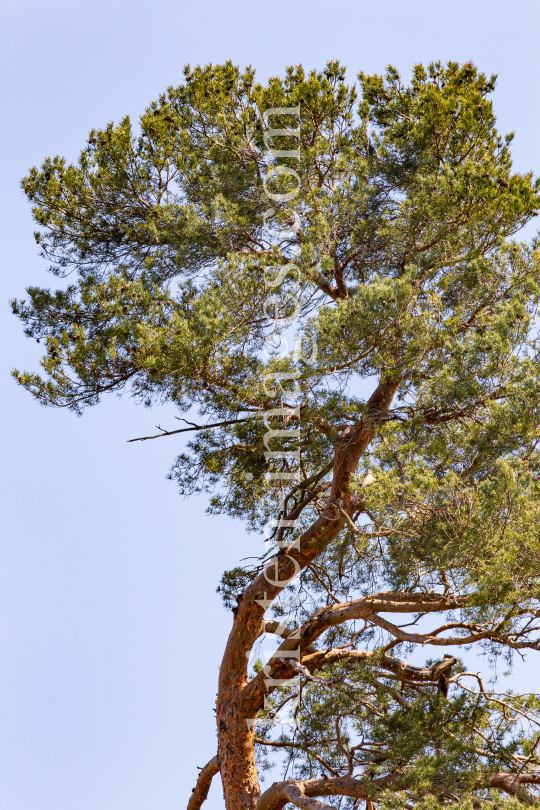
top-left (13, 62), bottom-right (540, 810)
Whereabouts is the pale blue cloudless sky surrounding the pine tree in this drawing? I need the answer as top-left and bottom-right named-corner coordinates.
top-left (0, 0), bottom-right (540, 810)
